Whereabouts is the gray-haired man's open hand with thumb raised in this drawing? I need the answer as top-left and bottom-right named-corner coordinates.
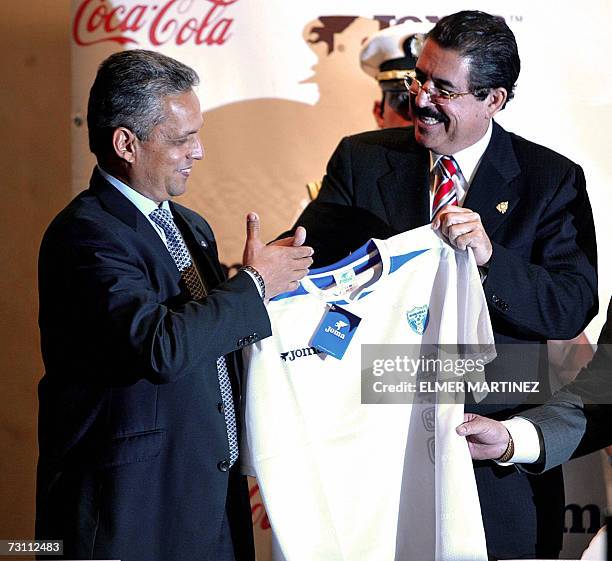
top-left (242, 212), bottom-right (314, 300)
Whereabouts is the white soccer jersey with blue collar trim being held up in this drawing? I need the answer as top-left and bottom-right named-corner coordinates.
top-left (241, 225), bottom-right (494, 561)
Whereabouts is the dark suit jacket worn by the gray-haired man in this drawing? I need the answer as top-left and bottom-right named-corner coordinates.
top-left (36, 167), bottom-right (270, 561)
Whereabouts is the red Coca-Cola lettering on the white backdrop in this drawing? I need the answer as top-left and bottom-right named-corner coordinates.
top-left (72, 0), bottom-right (239, 47)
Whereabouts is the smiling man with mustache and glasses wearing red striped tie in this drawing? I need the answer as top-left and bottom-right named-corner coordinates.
top-left (288, 11), bottom-right (597, 559)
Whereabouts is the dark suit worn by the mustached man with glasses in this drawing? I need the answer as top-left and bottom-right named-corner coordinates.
top-left (290, 123), bottom-right (597, 558)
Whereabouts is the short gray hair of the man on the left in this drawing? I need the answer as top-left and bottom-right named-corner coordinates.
top-left (87, 49), bottom-right (199, 158)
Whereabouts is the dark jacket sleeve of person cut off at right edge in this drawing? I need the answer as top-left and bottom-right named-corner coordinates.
top-left (521, 300), bottom-right (612, 471)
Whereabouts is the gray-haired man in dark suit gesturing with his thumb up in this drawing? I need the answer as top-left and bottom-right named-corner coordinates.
top-left (36, 50), bottom-right (312, 561)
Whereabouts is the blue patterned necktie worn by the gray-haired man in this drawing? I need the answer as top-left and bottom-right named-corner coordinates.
top-left (149, 208), bottom-right (238, 465)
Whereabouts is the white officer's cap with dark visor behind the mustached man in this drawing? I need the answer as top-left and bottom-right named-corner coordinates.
top-left (359, 21), bottom-right (431, 89)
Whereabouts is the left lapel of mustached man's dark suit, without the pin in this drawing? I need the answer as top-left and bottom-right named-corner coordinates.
top-left (378, 143), bottom-right (429, 232)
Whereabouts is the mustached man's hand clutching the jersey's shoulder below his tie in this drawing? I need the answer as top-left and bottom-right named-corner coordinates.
top-left (432, 205), bottom-right (493, 266)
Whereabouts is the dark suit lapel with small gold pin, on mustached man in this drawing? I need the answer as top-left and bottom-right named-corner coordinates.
top-left (463, 122), bottom-right (521, 237)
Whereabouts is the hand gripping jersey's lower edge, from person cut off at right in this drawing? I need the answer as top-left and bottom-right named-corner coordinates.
top-left (455, 413), bottom-right (510, 460)
